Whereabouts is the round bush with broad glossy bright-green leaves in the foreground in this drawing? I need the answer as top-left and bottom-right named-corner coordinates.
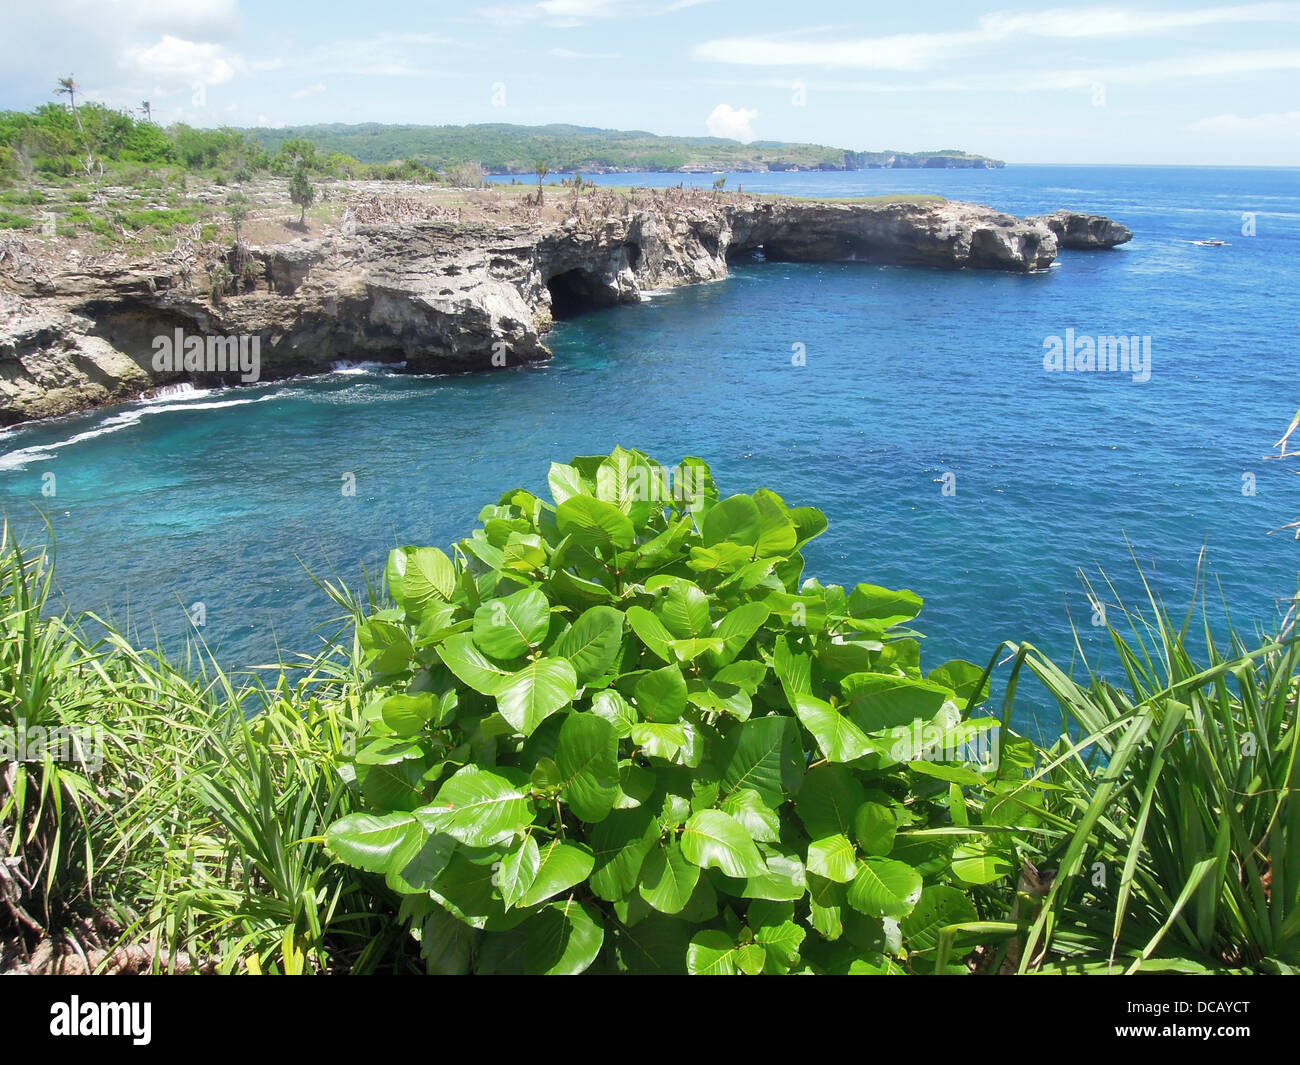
top-left (326, 449), bottom-right (1013, 973)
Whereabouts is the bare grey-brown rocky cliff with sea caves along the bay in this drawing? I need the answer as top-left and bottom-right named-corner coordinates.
top-left (0, 190), bottom-right (1131, 425)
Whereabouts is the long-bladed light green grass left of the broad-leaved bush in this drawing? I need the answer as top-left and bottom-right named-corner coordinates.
top-left (0, 529), bottom-right (412, 973)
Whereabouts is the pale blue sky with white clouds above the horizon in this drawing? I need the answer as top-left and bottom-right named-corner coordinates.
top-left (0, 0), bottom-right (1300, 166)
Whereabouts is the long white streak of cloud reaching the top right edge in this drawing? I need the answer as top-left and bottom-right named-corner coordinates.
top-left (692, 3), bottom-right (1300, 72)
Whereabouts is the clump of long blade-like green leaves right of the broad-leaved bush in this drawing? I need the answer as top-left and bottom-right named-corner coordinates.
top-left (1008, 566), bottom-right (1300, 973)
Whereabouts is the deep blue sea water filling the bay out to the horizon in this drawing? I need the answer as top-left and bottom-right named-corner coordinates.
top-left (0, 166), bottom-right (1300, 738)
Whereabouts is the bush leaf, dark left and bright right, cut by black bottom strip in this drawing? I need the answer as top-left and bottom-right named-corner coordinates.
top-left (477, 902), bottom-right (605, 977)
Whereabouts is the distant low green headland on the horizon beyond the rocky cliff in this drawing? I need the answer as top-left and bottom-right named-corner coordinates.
top-left (244, 122), bottom-right (1006, 174)
